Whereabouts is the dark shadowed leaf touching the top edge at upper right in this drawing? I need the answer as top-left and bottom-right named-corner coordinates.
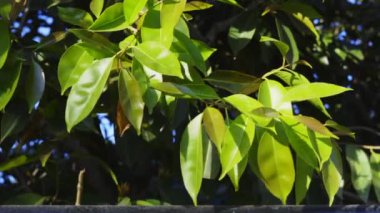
top-left (279, 0), bottom-right (323, 19)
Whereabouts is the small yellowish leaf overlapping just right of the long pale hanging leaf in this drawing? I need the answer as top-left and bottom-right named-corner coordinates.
top-left (203, 107), bottom-right (226, 153)
